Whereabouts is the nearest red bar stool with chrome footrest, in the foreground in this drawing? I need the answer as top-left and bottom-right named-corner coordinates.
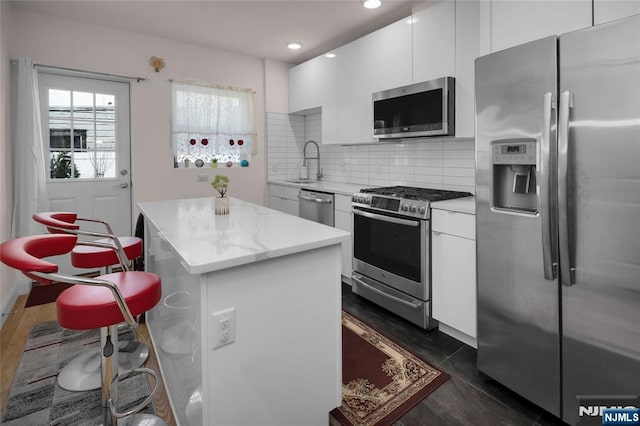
top-left (0, 234), bottom-right (165, 426)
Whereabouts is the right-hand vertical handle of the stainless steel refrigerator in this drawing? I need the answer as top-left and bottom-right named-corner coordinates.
top-left (558, 90), bottom-right (575, 286)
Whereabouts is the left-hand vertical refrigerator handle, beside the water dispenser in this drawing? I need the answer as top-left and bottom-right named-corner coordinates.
top-left (538, 92), bottom-right (558, 280)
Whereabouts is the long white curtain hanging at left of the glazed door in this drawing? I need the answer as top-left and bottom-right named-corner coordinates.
top-left (12, 58), bottom-right (49, 237)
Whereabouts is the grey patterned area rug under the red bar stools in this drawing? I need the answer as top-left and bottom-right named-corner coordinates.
top-left (0, 321), bottom-right (154, 426)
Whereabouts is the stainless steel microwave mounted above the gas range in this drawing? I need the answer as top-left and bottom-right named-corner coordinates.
top-left (373, 77), bottom-right (456, 139)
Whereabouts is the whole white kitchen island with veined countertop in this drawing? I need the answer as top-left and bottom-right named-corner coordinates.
top-left (139, 198), bottom-right (349, 425)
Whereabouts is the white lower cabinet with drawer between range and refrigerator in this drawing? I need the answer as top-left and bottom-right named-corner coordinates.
top-left (431, 209), bottom-right (477, 345)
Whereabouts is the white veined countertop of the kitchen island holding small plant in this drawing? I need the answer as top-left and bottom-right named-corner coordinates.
top-left (138, 197), bottom-right (350, 274)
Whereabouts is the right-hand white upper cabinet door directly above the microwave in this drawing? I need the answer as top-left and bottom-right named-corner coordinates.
top-left (412, 0), bottom-right (456, 83)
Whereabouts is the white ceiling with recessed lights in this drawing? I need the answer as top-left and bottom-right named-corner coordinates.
top-left (12, 0), bottom-right (424, 64)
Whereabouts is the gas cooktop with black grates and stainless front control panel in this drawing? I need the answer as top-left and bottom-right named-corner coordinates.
top-left (352, 186), bottom-right (472, 219)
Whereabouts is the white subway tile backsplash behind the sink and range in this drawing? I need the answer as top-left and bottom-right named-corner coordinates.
top-left (267, 113), bottom-right (475, 193)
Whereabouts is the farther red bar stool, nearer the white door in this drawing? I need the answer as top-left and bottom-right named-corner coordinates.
top-left (33, 212), bottom-right (149, 391)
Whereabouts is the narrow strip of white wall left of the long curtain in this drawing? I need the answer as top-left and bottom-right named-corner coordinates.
top-left (0, 1), bottom-right (16, 321)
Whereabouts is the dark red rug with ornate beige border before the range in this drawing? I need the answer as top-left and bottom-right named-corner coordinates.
top-left (331, 311), bottom-right (449, 426)
